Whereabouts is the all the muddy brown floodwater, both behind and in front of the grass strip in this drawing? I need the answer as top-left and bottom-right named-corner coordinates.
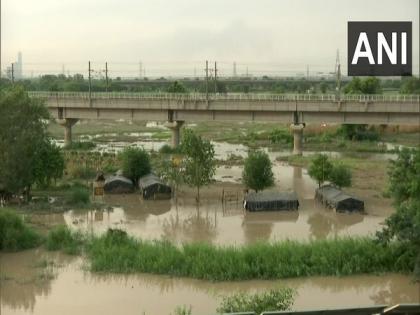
top-left (0, 135), bottom-right (420, 315)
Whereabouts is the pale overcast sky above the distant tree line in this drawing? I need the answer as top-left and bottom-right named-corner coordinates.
top-left (2, 0), bottom-right (419, 76)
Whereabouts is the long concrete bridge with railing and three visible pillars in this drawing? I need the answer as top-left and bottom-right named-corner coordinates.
top-left (29, 92), bottom-right (420, 154)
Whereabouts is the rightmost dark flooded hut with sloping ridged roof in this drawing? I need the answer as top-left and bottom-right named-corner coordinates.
top-left (315, 185), bottom-right (365, 212)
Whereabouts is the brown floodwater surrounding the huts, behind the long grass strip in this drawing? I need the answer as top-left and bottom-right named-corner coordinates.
top-left (28, 162), bottom-right (392, 244)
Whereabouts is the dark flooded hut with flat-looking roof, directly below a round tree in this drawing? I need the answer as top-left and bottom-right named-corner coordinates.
top-left (244, 191), bottom-right (299, 211)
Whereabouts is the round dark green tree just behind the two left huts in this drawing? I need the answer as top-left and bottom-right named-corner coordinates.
top-left (120, 148), bottom-right (152, 184)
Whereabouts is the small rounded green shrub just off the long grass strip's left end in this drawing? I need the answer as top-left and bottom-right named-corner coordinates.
top-left (46, 225), bottom-right (83, 255)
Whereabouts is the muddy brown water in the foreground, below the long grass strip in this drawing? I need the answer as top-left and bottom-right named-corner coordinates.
top-left (0, 250), bottom-right (420, 315)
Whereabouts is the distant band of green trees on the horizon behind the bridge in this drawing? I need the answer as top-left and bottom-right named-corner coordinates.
top-left (1, 74), bottom-right (420, 94)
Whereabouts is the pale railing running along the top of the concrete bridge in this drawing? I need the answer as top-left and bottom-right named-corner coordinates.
top-left (28, 91), bottom-right (420, 103)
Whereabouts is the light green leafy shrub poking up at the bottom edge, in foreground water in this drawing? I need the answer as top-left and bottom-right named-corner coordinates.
top-left (217, 288), bottom-right (296, 314)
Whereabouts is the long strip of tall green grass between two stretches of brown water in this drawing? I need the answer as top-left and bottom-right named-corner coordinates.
top-left (87, 230), bottom-right (414, 281)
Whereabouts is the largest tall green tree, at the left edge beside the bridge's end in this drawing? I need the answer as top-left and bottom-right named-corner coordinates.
top-left (0, 87), bottom-right (49, 198)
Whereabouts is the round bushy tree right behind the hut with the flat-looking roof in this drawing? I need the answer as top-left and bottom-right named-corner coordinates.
top-left (242, 151), bottom-right (274, 192)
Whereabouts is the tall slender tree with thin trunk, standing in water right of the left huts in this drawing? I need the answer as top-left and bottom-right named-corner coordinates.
top-left (181, 129), bottom-right (216, 200)
